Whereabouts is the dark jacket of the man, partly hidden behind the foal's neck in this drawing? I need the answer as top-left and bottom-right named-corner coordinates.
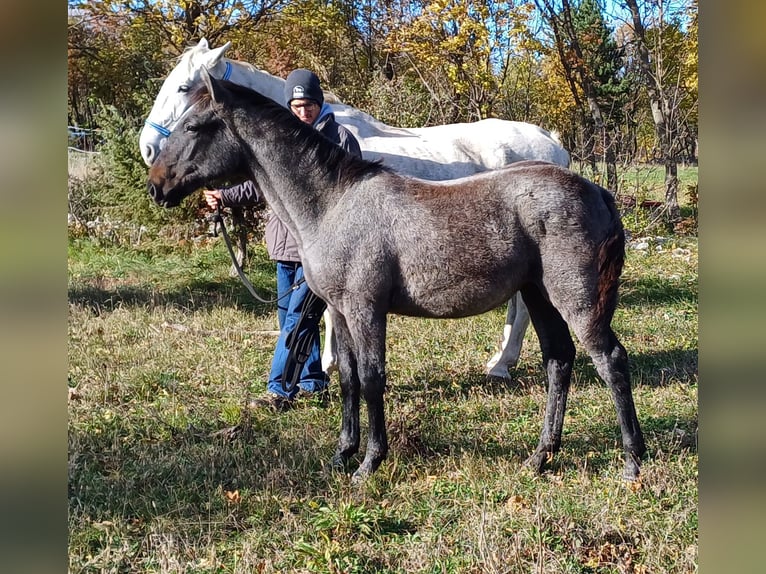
top-left (220, 104), bottom-right (362, 262)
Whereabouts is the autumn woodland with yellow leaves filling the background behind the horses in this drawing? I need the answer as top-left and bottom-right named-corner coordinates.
top-left (68, 0), bottom-right (697, 176)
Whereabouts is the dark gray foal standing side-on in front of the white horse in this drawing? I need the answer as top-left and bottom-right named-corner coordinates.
top-left (148, 74), bottom-right (646, 486)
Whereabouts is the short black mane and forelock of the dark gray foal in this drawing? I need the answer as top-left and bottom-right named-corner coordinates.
top-left (189, 80), bottom-right (391, 185)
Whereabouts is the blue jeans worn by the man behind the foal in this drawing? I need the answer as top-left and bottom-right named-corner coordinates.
top-left (267, 261), bottom-right (328, 399)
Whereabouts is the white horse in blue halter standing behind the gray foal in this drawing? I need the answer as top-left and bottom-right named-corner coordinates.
top-left (139, 38), bottom-right (569, 378)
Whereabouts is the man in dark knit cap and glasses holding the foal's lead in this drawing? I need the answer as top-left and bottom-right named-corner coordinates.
top-left (204, 69), bottom-right (362, 411)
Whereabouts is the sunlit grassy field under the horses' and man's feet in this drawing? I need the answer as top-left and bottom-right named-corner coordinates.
top-left (68, 225), bottom-right (698, 573)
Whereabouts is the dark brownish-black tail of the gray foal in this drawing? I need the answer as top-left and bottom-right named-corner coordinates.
top-left (591, 188), bottom-right (625, 333)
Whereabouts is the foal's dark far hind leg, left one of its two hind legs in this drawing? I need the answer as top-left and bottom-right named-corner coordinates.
top-left (523, 286), bottom-right (575, 472)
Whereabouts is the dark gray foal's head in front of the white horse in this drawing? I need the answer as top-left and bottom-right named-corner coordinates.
top-left (147, 68), bottom-right (248, 208)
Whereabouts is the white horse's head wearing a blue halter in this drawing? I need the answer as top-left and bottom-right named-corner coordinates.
top-left (138, 38), bottom-right (231, 166)
